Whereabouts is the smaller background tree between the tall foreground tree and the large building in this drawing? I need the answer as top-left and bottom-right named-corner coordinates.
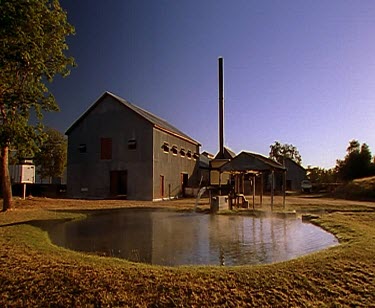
top-left (34, 127), bottom-right (68, 183)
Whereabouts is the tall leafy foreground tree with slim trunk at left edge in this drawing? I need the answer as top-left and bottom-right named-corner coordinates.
top-left (0, 0), bottom-right (74, 211)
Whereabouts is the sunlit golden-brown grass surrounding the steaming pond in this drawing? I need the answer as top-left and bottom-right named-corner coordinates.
top-left (0, 197), bottom-right (375, 307)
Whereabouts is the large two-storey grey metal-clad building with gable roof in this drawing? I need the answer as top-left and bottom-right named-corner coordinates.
top-left (66, 92), bottom-right (200, 200)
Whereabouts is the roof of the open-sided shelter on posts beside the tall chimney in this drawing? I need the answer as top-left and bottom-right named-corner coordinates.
top-left (221, 151), bottom-right (286, 172)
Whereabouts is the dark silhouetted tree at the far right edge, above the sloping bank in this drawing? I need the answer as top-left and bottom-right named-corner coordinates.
top-left (336, 140), bottom-right (373, 181)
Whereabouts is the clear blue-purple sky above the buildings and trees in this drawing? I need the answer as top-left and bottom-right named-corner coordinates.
top-left (49, 0), bottom-right (375, 168)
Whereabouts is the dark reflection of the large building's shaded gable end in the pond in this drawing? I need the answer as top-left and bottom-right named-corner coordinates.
top-left (50, 210), bottom-right (153, 263)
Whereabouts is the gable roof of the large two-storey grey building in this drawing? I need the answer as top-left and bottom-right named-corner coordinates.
top-left (65, 91), bottom-right (200, 145)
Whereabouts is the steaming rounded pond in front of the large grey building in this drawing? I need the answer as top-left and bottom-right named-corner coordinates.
top-left (42, 209), bottom-right (338, 266)
